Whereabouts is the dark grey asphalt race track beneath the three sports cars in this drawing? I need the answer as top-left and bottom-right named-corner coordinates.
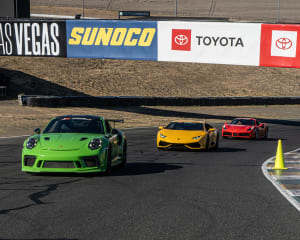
top-left (0, 121), bottom-right (300, 240)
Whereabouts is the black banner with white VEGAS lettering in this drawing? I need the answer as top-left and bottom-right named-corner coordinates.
top-left (0, 20), bottom-right (66, 57)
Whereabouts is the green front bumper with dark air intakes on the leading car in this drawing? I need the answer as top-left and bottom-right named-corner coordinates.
top-left (22, 149), bottom-right (107, 173)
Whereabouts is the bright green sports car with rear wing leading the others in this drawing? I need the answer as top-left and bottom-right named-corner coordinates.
top-left (22, 115), bottom-right (127, 173)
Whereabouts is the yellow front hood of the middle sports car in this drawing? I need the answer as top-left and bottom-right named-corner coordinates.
top-left (160, 129), bottom-right (205, 142)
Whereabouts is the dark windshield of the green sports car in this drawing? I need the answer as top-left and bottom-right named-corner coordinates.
top-left (43, 117), bottom-right (104, 134)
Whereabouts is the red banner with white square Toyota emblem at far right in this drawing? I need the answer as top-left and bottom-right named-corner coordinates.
top-left (260, 24), bottom-right (300, 68)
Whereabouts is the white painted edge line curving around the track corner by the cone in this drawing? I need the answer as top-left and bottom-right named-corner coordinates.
top-left (261, 148), bottom-right (300, 212)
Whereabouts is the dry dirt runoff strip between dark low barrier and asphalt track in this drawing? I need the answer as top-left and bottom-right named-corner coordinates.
top-left (0, 100), bottom-right (300, 137)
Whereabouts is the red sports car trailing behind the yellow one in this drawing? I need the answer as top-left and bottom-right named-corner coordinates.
top-left (222, 118), bottom-right (268, 139)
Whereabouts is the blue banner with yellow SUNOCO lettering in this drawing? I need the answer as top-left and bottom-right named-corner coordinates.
top-left (66, 20), bottom-right (157, 61)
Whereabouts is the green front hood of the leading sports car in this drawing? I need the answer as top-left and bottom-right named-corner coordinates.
top-left (40, 133), bottom-right (103, 151)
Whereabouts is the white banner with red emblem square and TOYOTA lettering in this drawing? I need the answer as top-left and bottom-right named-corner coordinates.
top-left (158, 21), bottom-right (261, 66)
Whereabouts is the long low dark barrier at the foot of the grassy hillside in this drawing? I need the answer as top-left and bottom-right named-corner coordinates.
top-left (19, 95), bottom-right (300, 107)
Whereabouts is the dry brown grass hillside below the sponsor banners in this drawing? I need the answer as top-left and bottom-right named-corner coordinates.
top-left (0, 57), bottom-right (300, 97)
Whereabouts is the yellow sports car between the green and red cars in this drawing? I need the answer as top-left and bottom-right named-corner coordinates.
top-left (157, 120), bottom-right (219, 150)
